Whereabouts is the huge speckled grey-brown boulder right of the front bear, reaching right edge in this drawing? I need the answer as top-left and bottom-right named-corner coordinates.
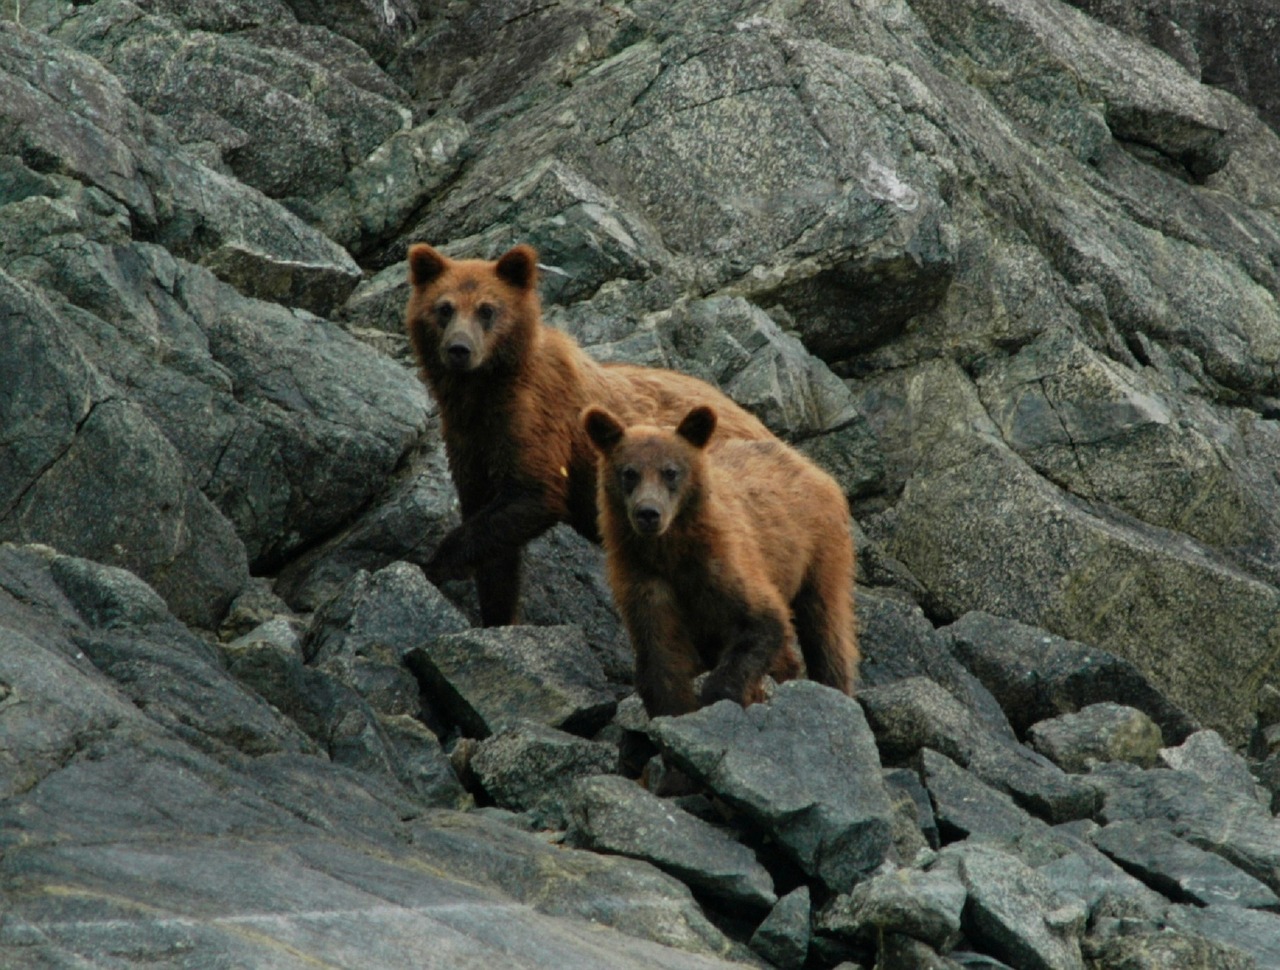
top-left (868, 365), bottom-right (1276, 740)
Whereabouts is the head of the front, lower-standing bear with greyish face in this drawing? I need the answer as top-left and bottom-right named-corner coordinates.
top-left (582, 406), bottom-right (716, 537)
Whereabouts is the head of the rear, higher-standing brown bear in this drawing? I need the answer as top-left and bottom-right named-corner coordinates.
top-left (406, 243), bottom-right (540, 375)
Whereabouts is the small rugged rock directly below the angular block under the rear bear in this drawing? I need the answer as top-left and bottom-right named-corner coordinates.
top-left (481, 722), bottom-right (619, 829)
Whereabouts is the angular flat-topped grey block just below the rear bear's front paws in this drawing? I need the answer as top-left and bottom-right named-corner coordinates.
top-left (404, 627), bottom-right (617, 738)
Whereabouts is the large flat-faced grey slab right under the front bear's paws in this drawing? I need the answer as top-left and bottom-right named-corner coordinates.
top-left (650, 681), bottom-right (893, 892)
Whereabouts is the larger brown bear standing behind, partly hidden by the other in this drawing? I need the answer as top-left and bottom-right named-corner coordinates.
top-left (406, 243), bottom-right (772, 626)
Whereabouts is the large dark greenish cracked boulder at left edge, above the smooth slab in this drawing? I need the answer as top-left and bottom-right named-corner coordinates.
top-left (0, 270), bottom-right (248, 627)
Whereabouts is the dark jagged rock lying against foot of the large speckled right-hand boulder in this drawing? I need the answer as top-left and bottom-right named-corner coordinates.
top-left (943, 613), bottom-right (1197, 742)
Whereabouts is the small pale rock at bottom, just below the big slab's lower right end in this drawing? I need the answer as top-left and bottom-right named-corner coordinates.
top-left (817, 865), bottom-right (968, 952)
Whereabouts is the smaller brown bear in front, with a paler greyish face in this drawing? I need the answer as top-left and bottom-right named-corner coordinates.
top-left (582, 406), bottom-right (859, 717)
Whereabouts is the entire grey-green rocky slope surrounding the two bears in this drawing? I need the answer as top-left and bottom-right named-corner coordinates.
top-left (0, 0), bottom-right (1280, 967)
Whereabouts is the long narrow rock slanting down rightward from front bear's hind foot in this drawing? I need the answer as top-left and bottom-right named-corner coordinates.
top-left (860, 677), bottom-right (1097, 822)
